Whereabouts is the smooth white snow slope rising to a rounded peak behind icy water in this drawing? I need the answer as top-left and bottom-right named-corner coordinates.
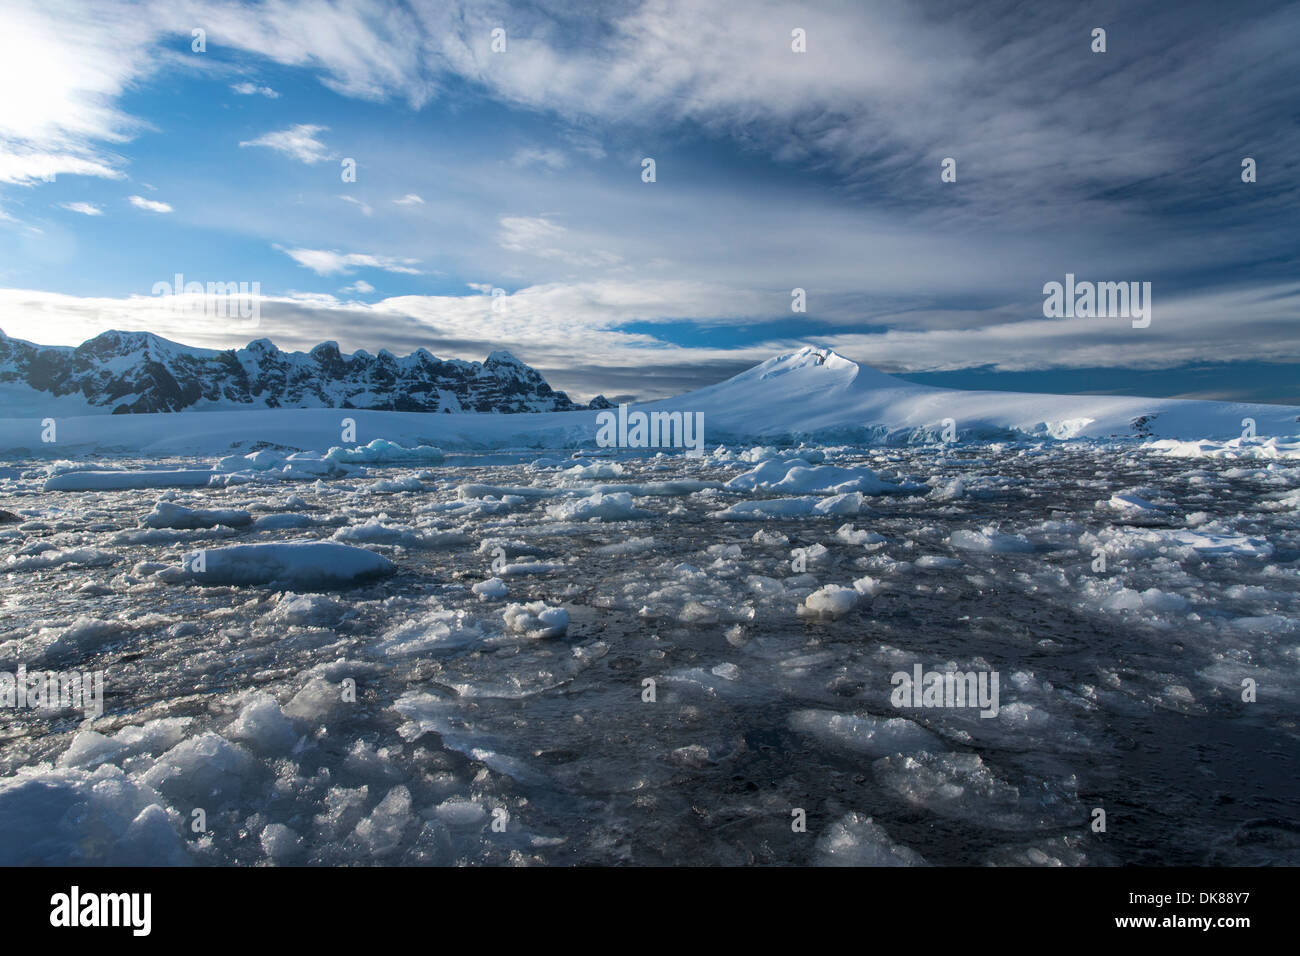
top-left (0, 347), bottom-right (1300, 458)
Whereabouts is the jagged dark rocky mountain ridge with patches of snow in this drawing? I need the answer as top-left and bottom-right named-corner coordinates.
top-left (0, 332), bottom-right (605, 415)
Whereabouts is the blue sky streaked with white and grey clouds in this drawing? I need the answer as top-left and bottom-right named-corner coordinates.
top-left (0, 0), bottom-right (1300, 403)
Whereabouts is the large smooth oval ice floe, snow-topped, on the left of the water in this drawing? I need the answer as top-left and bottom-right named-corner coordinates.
top-left (167, 541), bottom-right (394, 591)
